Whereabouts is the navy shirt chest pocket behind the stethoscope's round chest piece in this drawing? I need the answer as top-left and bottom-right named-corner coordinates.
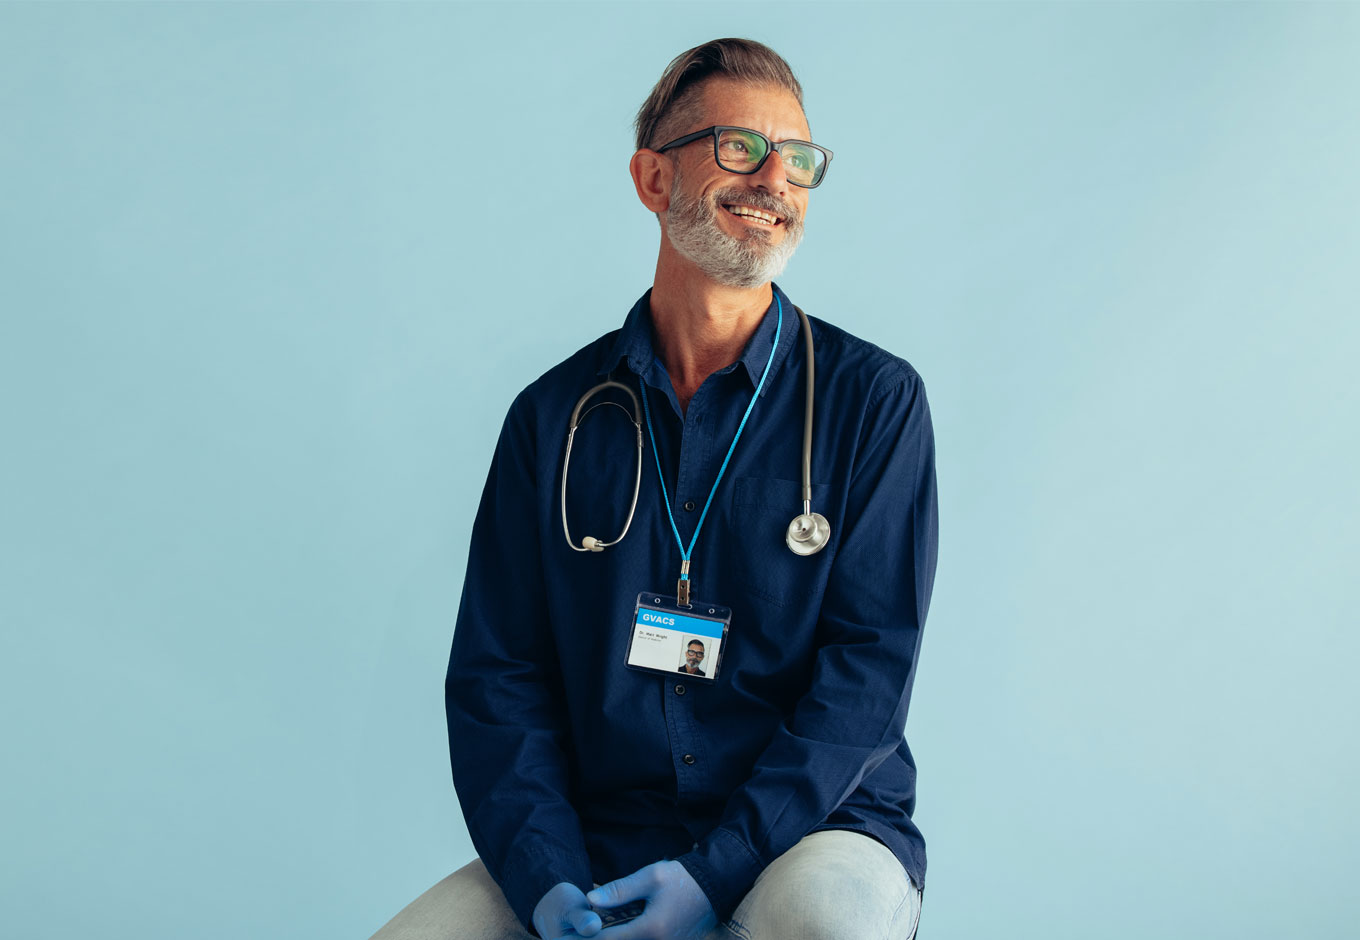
top-left (732, 476), bottom-right (836, 607)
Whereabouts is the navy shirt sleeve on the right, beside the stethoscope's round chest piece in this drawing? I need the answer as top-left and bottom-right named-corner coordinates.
top-left (677, 373), bottom-right (938, 918)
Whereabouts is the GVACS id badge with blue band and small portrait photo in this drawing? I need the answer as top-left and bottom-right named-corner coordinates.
top-left (627, 593), bottom-right (732, 682)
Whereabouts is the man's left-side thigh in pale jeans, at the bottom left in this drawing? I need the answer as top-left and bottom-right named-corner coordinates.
top-left (370, 858), bottom-right (533, 940)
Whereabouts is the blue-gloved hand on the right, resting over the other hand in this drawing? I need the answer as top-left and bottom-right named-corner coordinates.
top-left (586, 861), bottom-right (718, 940)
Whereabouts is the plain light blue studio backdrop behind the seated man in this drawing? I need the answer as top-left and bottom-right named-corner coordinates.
top-left (0, 3), bottom-right (1360, 940)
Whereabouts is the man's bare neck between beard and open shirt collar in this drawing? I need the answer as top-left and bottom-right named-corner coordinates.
top-left (651, 252), bottom-right (774, 411)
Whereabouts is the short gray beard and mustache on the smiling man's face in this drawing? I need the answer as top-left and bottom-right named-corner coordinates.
top-left (666, 175), bottom-right (802, 287)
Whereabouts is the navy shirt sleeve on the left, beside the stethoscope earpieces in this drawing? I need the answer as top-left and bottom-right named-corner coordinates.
top-left (445, 396), bottom-right (593, 932)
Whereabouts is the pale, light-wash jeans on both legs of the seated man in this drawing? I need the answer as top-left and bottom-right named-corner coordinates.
top-left (371, 830), bottom-right (921, 940)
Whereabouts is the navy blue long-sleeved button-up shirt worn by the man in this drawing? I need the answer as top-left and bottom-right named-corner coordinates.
top-left (445, 287), bottom-right (937, 926)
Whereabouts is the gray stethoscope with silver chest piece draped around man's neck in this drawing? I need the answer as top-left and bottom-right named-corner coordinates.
top-left (562, 306), bottom-right (831, 555)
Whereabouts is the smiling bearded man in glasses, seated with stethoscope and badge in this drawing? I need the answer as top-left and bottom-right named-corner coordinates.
top-left (378, 39), bottom-right (936, 940)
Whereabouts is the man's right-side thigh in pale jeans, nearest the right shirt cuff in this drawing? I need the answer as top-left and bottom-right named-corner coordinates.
top-left (714, 830), bottom-right (921, 940)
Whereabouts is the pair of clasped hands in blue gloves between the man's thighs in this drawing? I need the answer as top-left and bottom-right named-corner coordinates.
top-left (533, 861), bottom-right (718, 940)
